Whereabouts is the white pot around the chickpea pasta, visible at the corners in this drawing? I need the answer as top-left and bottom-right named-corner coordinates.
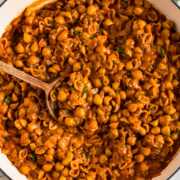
top-left (0, 0), bottom-right (180, 180)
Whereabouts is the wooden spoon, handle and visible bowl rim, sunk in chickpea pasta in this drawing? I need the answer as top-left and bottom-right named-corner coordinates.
top-left (0, 61), bottom-right (61, 119)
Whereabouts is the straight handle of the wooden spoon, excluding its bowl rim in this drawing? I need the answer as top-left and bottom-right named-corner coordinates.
top-left (0, 61), bottom-right (49, 91)
